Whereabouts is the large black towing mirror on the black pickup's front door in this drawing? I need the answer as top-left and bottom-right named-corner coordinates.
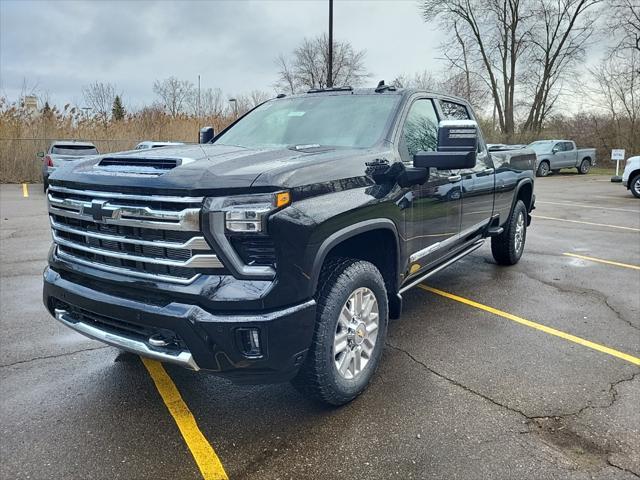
top-left (413, 120), bottom-right (478, 170)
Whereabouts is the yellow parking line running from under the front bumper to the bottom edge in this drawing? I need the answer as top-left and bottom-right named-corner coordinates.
top-left (142, 358), bottom-right (229, 480)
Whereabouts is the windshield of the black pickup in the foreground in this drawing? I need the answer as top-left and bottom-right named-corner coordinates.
top-left (215, 94), bottom-right (400, 150)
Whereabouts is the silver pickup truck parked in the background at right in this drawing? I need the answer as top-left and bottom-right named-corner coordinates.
top-left (528, 140), bottom-right (596, 177)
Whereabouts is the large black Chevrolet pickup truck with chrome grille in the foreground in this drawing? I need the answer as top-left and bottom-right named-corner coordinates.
top-left (43, 86), bottom-right (535, 405)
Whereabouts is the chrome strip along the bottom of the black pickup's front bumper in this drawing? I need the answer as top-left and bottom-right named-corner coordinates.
top-left (55, 308), bottom-right (200, 370)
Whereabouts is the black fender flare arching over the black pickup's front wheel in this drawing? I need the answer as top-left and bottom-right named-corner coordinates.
top-left (310, 218), bottom-right (400, 295)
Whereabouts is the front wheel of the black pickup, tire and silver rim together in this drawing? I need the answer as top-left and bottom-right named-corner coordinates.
top-left (291, 258), bottom-right (389, 405)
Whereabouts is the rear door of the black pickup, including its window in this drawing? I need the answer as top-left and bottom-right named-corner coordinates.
top-left (440, 100), bottom-right (495, 235)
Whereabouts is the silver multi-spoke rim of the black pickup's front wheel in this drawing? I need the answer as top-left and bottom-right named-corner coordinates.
top-left (333, 287), bottom-right (380, 380)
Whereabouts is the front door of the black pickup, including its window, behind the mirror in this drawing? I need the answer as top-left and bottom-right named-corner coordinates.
top-left (399, 98), bottom-right (462, 275)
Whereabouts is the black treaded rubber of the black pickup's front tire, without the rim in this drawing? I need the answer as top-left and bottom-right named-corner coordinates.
top-left (291, 258), bottom-right (389, 405)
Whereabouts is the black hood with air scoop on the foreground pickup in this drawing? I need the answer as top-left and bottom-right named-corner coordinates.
top-left (50, 144), bottom-right (384, 196)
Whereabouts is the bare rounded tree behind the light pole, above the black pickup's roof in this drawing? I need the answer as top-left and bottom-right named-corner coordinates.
top-left (276, 35), bottom-right (369, 93)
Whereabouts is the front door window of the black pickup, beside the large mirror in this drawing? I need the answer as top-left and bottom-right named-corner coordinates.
top-left (400, 98), bottom-right (438, 162)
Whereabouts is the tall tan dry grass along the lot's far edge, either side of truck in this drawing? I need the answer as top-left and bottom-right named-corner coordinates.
top-left (0, 97), bottom-right (640, 183)
